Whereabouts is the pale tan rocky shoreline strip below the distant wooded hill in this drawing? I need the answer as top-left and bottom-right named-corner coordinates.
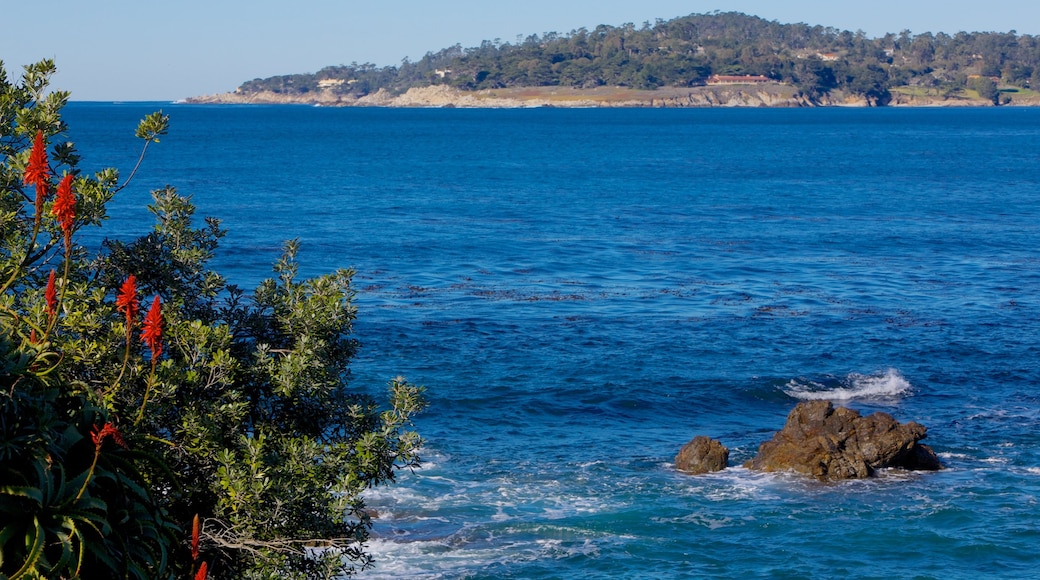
top-left (181, 83), bottom-right (1040, 108)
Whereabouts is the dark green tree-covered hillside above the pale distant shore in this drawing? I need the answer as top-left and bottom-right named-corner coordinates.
top-left (238, 12), bottom-right (1040, 103)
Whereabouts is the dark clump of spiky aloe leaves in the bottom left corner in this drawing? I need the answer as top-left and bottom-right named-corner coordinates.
top-left (0, 386), bottom-right (170, 579)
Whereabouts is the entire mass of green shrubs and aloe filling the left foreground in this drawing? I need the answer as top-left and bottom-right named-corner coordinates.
top-left (0, 61), bottom-right (425, 578)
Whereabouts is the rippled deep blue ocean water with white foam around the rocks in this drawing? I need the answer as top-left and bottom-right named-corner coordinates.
top-left (66, 103), bottom-right (1040, 579)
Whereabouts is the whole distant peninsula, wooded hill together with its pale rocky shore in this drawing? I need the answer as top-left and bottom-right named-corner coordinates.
top-left (186, 12), bottom-right (1040, 108)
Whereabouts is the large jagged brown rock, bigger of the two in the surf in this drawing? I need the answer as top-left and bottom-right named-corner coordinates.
top-left (745, 401), bottom-right (942, 480)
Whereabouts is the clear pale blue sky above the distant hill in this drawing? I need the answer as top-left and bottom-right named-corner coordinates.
top-left (0, 0), bottom-right (1040, 101)
